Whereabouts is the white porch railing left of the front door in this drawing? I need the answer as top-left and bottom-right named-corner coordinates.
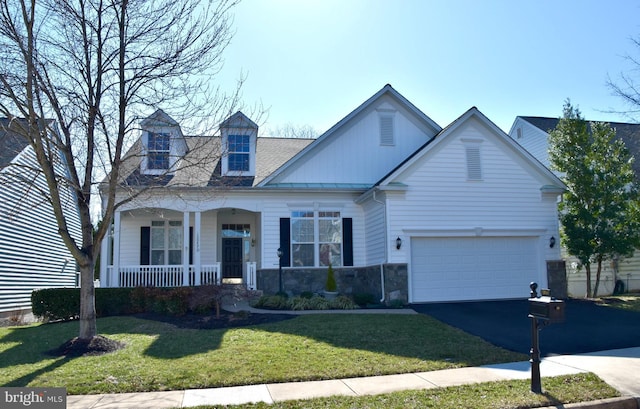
top-left (115, 263), bottom-right (221, 287)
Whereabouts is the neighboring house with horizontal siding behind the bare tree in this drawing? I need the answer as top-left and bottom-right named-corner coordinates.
top-left (0, 118), bottom-right (80, 317)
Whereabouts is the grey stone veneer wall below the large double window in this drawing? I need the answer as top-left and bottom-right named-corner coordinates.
top-left (256, 264), bottom-right (409, 304)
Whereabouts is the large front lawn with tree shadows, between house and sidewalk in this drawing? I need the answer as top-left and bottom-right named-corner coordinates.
top-left (0, 314), bottom-right (528, 394)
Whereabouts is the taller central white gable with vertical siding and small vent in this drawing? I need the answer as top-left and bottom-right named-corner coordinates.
top-left (264, 85), bottom-right (440, 188)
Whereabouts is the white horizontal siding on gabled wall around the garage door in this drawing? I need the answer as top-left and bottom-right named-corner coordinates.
top-left (387, 121), bottom-right (559, 262)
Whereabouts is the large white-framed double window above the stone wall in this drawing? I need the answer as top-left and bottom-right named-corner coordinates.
top-left (291, 210), bottom-right (342, 267)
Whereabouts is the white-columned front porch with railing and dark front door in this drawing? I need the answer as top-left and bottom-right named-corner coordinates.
top-left (100, 208), bottom-right (260, 290)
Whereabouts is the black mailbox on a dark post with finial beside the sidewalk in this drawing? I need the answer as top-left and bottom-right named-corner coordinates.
top-left (529, 283), bottom-right (564, 393)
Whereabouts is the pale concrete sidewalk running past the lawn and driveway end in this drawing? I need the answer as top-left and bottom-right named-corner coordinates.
top-left (67, 347), bottom-right (640, 409)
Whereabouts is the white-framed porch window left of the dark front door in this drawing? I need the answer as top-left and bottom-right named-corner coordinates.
top-left (150, 220), bottom-right (183, 265)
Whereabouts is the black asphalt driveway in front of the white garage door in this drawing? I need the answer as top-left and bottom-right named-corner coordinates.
top-left (411, 300), bottom-right (640, 356)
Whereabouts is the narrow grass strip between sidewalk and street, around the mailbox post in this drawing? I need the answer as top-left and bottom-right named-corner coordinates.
top-left (186, 373), bottom-right (620, 409)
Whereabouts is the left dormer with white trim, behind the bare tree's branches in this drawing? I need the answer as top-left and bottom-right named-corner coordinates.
top-left (140, 109), bottom-right (187, 175)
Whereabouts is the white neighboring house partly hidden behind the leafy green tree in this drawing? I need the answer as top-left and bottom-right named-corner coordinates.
top-left (509, 116), bottom-right (640, 297)
